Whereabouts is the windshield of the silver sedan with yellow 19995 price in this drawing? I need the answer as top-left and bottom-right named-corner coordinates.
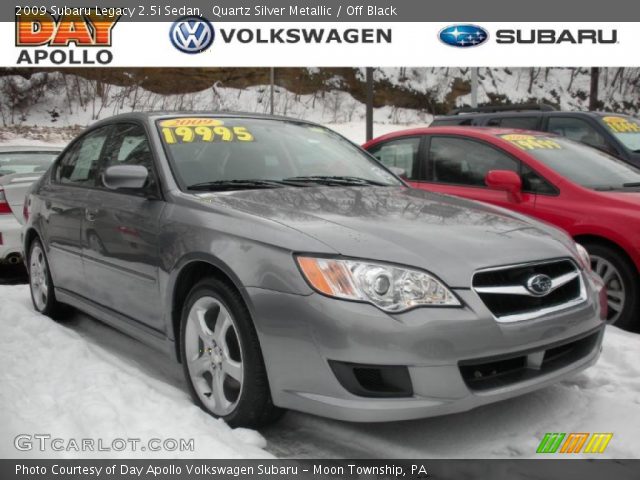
top-left (157, 117), bottom-right (401, 190)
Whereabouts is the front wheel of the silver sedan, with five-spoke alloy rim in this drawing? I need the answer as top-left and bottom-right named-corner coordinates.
top-left (180, 278), bottom-right (283, 428)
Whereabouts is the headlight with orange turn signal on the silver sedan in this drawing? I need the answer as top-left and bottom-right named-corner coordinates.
top-left (296, 257), bottom-right (460, 313)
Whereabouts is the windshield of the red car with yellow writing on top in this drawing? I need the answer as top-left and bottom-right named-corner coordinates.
top-left (501, 134), bottom-right (640, 191)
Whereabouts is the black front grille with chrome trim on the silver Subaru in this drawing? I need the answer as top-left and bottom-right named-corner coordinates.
top-left (473, 259), bottom-right (586, 322)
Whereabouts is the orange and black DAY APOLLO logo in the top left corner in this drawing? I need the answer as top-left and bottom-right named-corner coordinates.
top-left (15, 7), bottom-right (120, 65)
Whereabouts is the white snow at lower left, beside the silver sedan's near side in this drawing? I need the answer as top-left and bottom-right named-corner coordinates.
top-left (0, 285), bottom-right (271, 458)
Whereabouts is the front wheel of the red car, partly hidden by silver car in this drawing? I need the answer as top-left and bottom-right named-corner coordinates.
top-left (583, 242), bottom-right (640, 330)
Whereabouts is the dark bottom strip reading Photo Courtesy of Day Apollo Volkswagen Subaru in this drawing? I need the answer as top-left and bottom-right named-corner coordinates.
top-left (0, 459), bottom-right (640, 480)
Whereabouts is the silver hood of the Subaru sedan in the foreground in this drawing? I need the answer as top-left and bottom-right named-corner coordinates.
top-left (199, 187), bottom-right (572, 287)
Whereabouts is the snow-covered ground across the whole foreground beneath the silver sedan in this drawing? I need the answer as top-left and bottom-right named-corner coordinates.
top-left (0, 285), bottom-right (640, 458)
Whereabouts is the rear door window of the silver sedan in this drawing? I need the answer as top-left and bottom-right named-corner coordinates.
top-left (56, 127), bottom-right (110, 186)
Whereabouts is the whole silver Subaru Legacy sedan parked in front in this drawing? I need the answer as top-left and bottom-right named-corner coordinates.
top-left (24, 112), bottom-right (606, 427)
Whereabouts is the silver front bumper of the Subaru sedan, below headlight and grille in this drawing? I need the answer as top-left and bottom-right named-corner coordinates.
top-left (247, 278), bottom-right (604, 422)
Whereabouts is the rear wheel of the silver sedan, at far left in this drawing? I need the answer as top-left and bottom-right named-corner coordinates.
top-left (27, 238), bottom-right (70, 321)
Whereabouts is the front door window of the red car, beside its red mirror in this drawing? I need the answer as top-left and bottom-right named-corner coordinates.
top-left (429, 137), bottom-right (520, 187)
